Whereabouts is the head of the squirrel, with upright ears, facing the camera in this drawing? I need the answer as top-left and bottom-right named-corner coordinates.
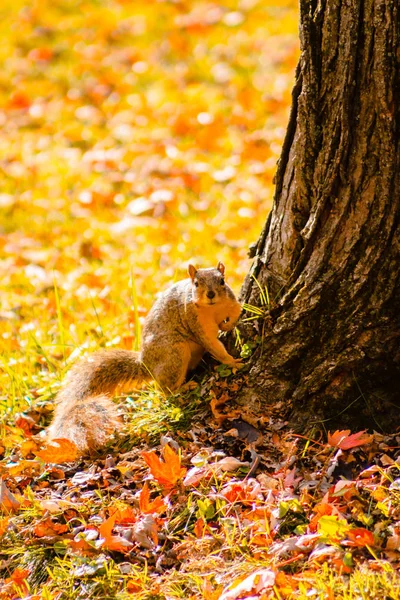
top-left (188, 262), bottom-right (226, 306)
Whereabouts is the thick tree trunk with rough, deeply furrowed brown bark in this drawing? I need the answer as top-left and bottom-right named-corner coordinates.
top-left (239, 0), bottom-right (400, 430)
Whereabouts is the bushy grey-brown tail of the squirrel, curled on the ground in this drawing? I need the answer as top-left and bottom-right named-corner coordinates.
top-left (48, 350), bottom-right (148, 454)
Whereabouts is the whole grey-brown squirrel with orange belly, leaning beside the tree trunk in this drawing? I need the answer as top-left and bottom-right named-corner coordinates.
top-left (47, 262), bottom-right (242, 454)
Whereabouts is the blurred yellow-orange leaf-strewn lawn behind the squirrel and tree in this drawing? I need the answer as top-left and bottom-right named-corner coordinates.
top-left (0, 0), bottom-right (299, 402)
